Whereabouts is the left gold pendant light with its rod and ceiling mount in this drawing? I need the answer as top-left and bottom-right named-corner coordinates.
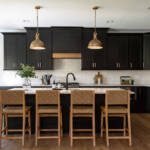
top-left (30, 6), bottom-right (45, 50)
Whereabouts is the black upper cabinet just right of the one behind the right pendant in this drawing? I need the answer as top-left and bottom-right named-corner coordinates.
top-left (106, 34), bottom-right (128, 70)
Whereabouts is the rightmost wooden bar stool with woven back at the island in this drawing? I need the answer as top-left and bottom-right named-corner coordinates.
top-left (101, 90), bottom-right (132, 146)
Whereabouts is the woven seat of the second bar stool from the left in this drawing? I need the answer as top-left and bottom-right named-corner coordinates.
top-left (37, 106), bottom-right (58, 114)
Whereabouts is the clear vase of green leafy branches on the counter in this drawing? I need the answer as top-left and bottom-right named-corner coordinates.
top-left (17, 64), bottom-right (35, 87)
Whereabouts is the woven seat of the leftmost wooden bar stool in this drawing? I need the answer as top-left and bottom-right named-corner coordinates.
top-left (3, 106), bottom-right (30, 115)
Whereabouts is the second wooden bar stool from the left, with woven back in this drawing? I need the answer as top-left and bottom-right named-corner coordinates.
top-left (35, 90), bottom-right (62, 146)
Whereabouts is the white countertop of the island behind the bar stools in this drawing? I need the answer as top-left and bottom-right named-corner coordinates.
top-left (10, 88), bottom-right (134, 94)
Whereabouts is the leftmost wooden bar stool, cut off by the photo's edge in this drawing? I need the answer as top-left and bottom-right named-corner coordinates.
top-left (0, 90), bottom-right (31, 146)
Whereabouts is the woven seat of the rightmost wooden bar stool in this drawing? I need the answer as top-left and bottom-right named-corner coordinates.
top-left (101, 106), bottom-right (128, 114)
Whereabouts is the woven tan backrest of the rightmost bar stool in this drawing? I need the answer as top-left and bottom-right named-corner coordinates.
top-left (105, 90), bottom-right (130, 106)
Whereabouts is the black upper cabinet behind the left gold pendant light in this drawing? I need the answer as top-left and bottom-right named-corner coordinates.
top-left (26, 28), bottom-right (53, 70)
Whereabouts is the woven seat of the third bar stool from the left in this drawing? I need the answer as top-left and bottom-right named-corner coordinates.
top-left (73, 106), bottom-right (93, 114)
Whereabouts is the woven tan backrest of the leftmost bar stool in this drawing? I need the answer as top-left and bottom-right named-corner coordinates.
top-left (0, 90), bottom-right (25, 105)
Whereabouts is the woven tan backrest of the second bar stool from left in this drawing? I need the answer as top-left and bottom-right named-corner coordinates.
top-left (36, 90), bottom-right (60, 105)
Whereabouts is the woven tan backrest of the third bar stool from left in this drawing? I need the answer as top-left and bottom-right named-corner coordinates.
top-left (71, 90), bottom-right (95, 105)
